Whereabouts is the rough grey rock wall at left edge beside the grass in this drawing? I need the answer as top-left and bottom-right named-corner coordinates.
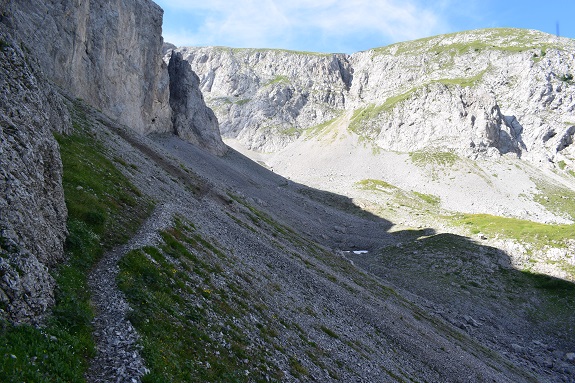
top-left (0, 27), bottom-right (71, 322)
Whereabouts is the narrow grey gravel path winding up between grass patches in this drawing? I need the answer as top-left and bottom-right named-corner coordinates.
top-left (86, 204), bottom-right (176, 383)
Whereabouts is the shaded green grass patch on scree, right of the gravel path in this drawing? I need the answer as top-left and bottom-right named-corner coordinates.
top-left (118, 220), bottom-right (282, 382)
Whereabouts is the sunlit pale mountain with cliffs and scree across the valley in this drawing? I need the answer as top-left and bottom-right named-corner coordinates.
top-left (177, 29), bottom-right (575, 280)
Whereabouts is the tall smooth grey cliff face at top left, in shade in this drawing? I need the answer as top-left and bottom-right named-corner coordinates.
top-left (7, 0), bottom-right (172, 134)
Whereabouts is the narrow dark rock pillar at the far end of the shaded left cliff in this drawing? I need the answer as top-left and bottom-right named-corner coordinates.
top-left (168, 52), bottom-right (227, 155)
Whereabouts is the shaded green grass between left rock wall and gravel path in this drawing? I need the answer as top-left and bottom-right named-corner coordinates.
top-left (0, 100), bottom-right (150, 382)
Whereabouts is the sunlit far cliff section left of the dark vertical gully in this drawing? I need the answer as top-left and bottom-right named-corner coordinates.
top-left (178, 47), bottom-right (352, 151)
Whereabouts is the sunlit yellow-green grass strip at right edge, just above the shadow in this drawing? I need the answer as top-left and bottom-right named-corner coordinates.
top-left (452, 214), bottom-right (575, 248)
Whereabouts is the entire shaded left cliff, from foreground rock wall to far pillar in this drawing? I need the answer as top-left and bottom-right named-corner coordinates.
top-left (0, 0), bottom-right (226, 322)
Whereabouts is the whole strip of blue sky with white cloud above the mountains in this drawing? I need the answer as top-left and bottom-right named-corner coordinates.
top-left (155, 0), bottom-right (575, 53)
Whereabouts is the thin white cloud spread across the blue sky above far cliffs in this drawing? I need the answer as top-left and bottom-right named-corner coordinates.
top-left (157, 0), bottom-right (460, 50)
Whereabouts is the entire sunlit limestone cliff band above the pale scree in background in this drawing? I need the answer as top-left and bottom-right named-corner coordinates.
top-left (180, 29), bottom-right (575, 162)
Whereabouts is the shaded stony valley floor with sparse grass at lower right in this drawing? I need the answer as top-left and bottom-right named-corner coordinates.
top-left (350, 229), bottom-right (575, 371)
